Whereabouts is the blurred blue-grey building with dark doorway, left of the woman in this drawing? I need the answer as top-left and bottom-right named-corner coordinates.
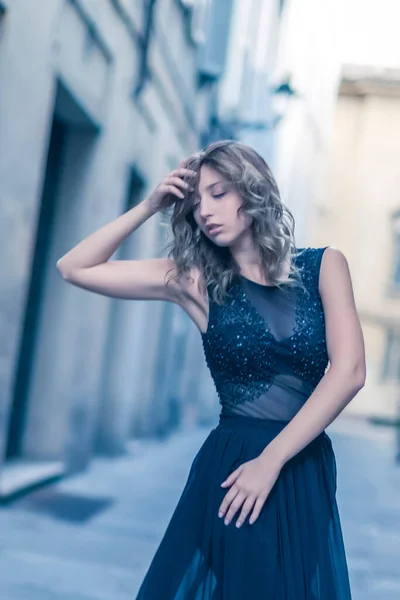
top-left (0, 0), bottom-right (228, 495)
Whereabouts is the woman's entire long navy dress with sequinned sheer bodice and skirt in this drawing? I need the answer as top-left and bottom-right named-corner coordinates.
top-left (137, 248), bottom-right (351, 600)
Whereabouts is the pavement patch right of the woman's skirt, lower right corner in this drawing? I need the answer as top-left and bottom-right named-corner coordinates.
top-left (328, 419), bottom-right (400, 600)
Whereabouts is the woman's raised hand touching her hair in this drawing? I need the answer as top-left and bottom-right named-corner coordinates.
top-left (146, 162), bottom-right (197, 212)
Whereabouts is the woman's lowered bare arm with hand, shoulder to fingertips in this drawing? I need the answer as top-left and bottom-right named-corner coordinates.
top-left (218, 247), bottom-right (366, 527)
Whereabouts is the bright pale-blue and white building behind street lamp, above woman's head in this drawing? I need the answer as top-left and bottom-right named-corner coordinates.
top-left (210, 0), bottom-right (342, 246)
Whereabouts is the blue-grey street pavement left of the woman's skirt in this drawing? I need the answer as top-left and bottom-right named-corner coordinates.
top-left (0, 427), bottom-right (211, 600)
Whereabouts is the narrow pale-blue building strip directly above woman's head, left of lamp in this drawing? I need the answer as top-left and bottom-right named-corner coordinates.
top-left (209, 0), bottom-right (287, 167)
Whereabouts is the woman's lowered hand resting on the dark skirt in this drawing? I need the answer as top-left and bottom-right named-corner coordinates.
top-left (218, 454), bottom-right (282, 527)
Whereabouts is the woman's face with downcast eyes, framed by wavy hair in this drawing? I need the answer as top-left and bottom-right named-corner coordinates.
top-left (193, 165), bottom-right (251, 246)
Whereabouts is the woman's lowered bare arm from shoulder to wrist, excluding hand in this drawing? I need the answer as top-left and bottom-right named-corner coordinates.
top-left (260, 247), bottom-right (366, 466)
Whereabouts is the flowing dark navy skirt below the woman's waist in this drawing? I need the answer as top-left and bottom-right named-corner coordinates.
top-left (136, 415), bottom-right (351, 600)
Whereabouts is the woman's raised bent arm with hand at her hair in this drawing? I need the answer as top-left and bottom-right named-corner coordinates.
top-left (57, 168), bottom-right (197, 303)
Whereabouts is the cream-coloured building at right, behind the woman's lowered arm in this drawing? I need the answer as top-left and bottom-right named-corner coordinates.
top-left (314, 65), bottom-right (400, 421)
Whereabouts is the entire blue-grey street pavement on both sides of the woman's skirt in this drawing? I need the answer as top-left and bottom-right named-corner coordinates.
top-left (0, 420), bottom-right (400, 600)
